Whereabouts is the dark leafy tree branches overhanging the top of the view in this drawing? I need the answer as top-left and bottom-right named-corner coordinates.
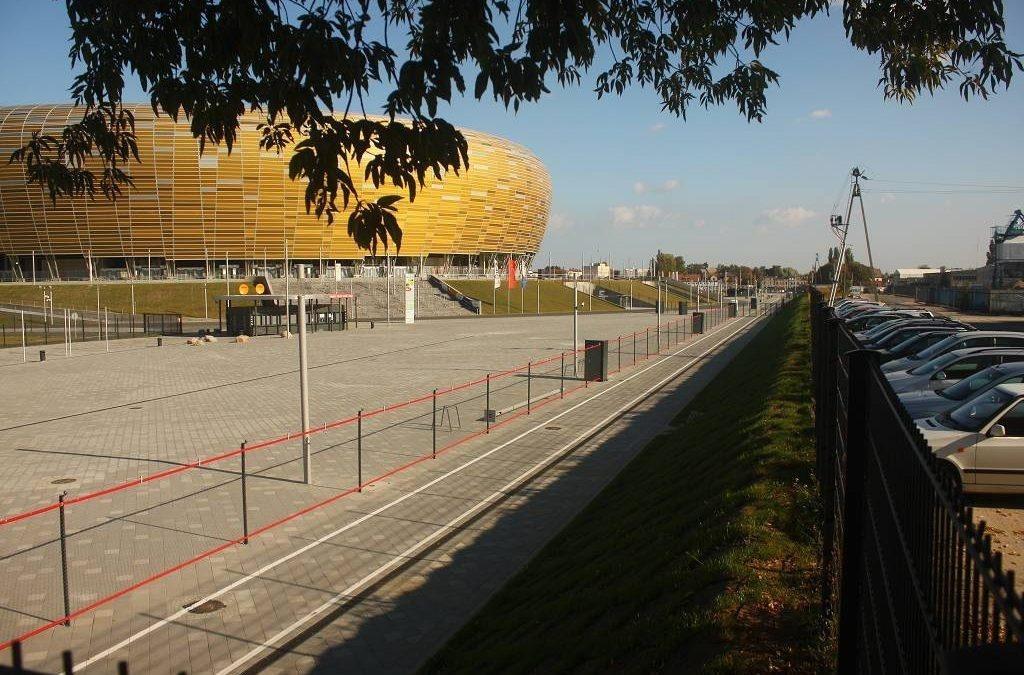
top-left (11, 0), bottom-right (1021, 251)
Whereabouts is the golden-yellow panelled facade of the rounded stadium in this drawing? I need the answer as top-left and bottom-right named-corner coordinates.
top-left (0, 104), bottom-right (551, 278)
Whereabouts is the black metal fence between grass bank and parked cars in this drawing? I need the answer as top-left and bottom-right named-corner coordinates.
top-left (811, 291), bottom-right (1024, 673)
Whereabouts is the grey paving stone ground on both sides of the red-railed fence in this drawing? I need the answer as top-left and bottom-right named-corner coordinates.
top-left (0, 303), bottom-right (774, 672)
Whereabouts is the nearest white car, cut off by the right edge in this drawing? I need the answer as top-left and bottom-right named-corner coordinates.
top-left (918, 384), bottom-right (1024, 494)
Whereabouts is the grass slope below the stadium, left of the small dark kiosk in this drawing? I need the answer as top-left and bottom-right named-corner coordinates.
top-left (0, 281), bottom-right (241, 318)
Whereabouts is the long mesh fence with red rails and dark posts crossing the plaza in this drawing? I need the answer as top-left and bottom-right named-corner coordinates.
top-left (0, 300), bottom-right (780, 650)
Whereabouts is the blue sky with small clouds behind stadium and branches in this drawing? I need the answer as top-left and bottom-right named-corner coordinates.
top-left (0, 0), bottom-right (1024, 269)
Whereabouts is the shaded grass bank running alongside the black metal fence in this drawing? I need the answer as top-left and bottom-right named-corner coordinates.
top-left (424, 292), bottom-right (821, 673)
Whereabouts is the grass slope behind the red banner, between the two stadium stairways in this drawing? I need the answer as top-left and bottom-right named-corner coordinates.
top-left (445, 279), bottom-right (623, 314)
